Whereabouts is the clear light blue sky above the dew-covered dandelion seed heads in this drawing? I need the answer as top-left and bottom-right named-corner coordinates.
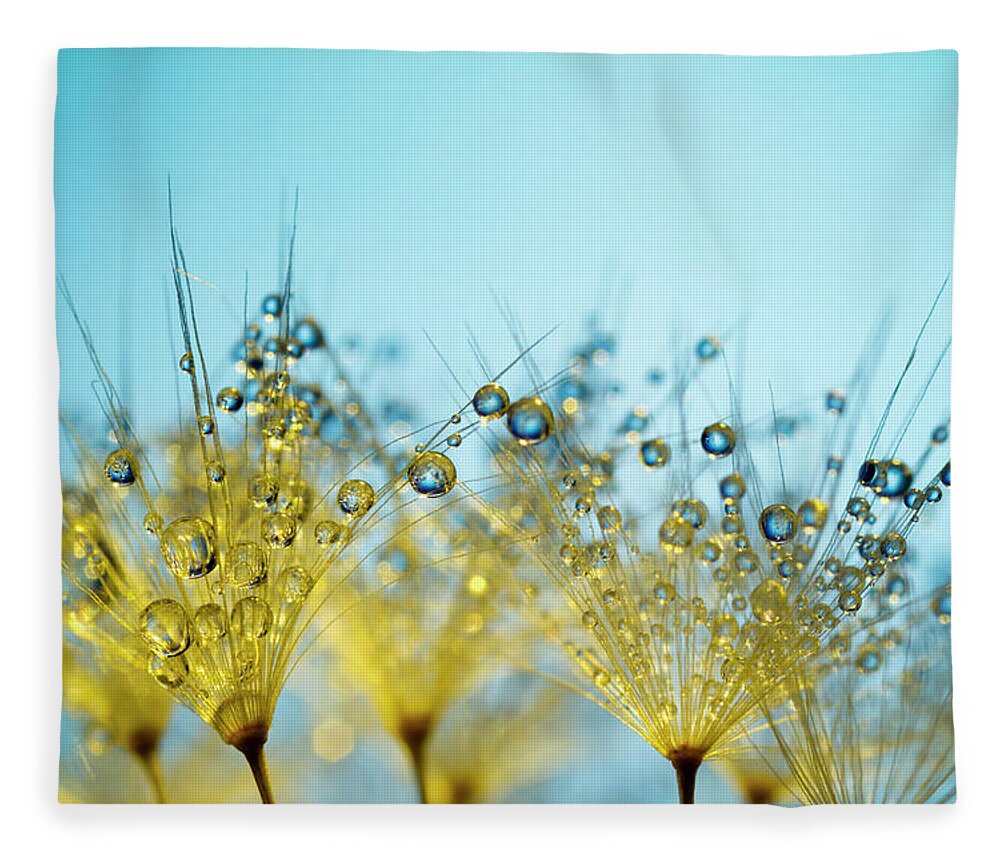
top-left (55, 49), bottom-right (957, 800)
